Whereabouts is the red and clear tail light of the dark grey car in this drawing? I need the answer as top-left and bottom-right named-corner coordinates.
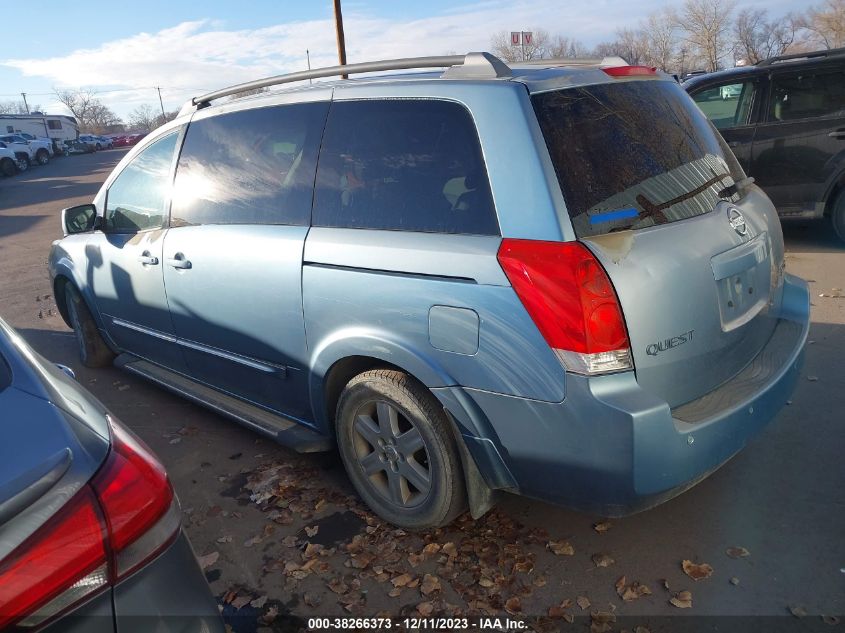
top-left (0, 420), bottom-right (180, 630)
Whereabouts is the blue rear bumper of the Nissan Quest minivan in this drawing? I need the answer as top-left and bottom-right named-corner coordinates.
top-left (441, 275), bottom-right (810, 516)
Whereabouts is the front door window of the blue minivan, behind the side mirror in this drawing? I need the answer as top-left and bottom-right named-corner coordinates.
top-left (103, 132), bottom-right (179, 233)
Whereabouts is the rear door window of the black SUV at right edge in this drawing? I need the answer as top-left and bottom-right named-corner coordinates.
top-left (769, 71), bottom-right (845, 121)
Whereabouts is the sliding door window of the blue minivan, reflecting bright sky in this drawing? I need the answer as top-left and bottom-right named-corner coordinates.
top-left (170, 103), bottom-right (329, 227)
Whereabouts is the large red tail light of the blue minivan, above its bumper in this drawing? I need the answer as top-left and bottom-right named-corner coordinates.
top-left (498, 239), bottom-right (633, 375)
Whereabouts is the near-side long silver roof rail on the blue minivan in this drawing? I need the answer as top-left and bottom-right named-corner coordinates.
top-left (183, 53), bottom-right (511, 110)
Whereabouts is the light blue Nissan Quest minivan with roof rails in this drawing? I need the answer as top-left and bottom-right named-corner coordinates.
top-left (49, 53), bottom-right (809, 528)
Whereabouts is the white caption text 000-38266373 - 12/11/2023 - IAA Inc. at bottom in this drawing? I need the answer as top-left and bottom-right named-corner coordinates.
top-left (308, 617), bottom-right (528, 631)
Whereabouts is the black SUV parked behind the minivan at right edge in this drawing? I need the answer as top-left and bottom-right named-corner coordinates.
top-left (684, 48), bottom-right (845, 240)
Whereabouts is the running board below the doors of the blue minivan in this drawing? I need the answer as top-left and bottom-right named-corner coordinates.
top-left (114, 354), bottom-right (334, 453)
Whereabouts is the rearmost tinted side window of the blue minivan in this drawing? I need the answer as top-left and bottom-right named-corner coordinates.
top-left (313, 100), bottom-right (499, 235)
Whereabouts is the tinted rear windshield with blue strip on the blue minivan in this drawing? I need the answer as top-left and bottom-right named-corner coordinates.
top-left (532, 81), bottom-right (745, 237)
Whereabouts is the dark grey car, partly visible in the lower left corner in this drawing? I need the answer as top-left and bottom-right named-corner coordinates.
top-left (0, 320), bottom-right (223, 633)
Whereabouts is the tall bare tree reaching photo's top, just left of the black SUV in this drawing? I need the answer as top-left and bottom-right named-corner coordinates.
top-left (671, 0), bottom-right (734, 72)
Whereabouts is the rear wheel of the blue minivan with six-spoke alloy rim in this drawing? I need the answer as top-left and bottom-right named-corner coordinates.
top-left (336, 369), bottom-right (466, 530)
